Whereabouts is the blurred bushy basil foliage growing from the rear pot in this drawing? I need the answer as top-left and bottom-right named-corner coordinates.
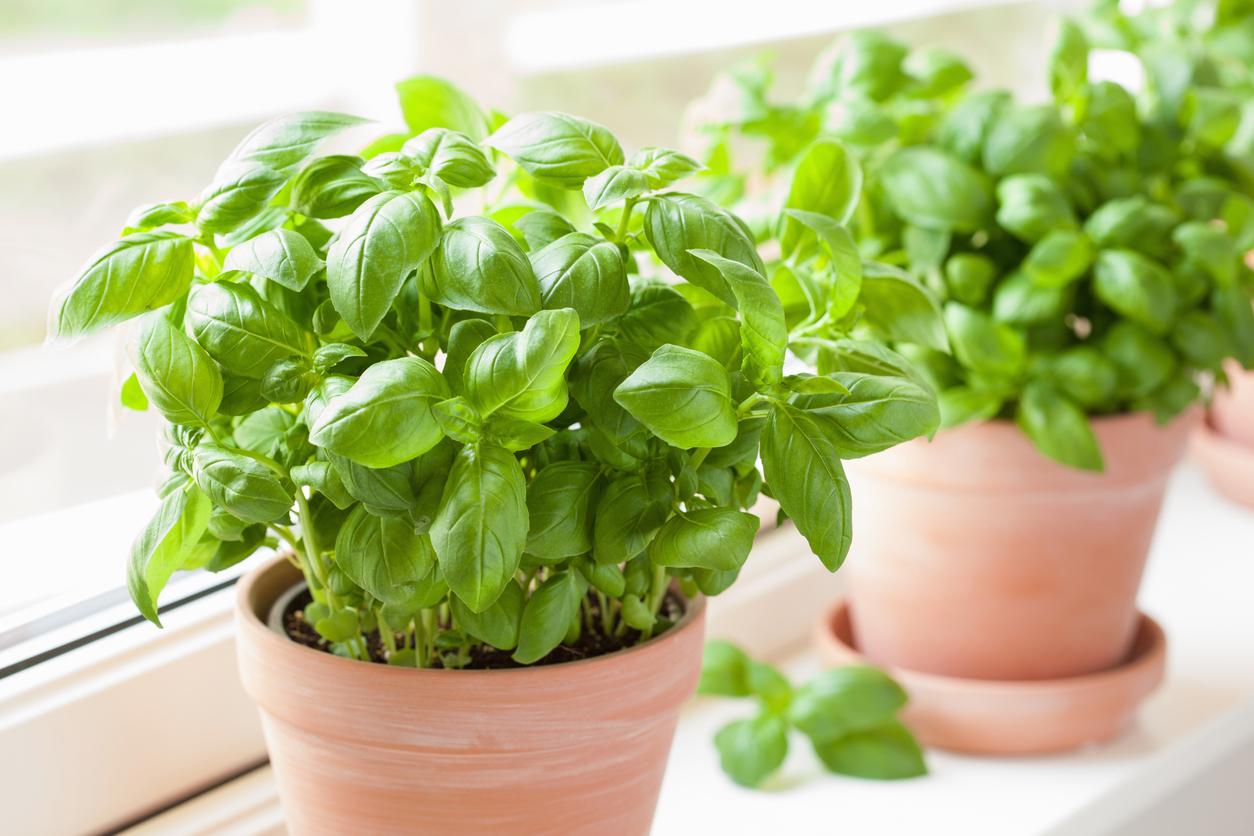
top-left (703, 25), bottom-right (1254, 470)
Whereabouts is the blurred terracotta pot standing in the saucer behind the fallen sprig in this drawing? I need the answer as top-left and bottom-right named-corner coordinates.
top-left (845, 414), bottom-right (1196, 679)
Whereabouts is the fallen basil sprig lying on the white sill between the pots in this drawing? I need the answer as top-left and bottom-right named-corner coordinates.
top-left (697, 642), bottom-right (928, 787)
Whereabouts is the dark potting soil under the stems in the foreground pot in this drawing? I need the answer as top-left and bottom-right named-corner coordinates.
top-left (283, 589), bottom-right (683, 671)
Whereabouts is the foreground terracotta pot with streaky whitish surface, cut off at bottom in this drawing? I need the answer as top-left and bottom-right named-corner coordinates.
top-left (236, 559), bottom-right (705, 836)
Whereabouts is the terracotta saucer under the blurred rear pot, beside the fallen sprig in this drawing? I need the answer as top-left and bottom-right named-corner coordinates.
top-left (815, 600), bottom-right (1166, 755)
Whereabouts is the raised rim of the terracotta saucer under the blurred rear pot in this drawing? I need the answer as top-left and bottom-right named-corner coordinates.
top-left (814, 595), bottom-right (1167, 697)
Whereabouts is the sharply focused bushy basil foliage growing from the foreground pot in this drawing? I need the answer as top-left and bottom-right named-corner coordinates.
top-left (50, 78), bottom-right (937, 667)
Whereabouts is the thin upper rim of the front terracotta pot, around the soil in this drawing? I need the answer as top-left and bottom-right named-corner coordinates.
top-left (234, 553), bottom-right (706, 681)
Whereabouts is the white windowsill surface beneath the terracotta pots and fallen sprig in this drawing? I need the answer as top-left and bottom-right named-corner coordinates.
top-left (115, 465), bottom-right (1254, 836)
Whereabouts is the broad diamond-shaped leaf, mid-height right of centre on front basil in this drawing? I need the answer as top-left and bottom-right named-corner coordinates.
top-left (614, 345), bottom-right (736, 449)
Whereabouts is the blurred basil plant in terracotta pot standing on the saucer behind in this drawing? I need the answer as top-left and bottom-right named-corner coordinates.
top-left (706, 26), bottom-right (1254, 747)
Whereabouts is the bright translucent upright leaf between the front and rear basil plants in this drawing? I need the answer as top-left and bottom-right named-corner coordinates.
top-left (780, 139), bottom-right (863, 256)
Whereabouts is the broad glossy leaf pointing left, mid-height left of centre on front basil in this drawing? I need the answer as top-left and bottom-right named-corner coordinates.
top-left (310, 357), bottom-right (450, 468)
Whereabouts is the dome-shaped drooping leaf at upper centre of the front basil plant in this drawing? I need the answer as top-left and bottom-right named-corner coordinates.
top-left (423, 216), bottom-right (540, 316)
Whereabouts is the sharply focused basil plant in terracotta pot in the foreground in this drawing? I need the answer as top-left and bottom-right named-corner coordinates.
top-left (51, 78), bottom-right (934, 833)
